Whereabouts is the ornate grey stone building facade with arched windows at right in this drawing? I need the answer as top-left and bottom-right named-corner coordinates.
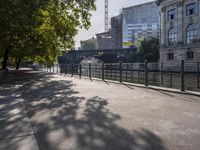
top-left (157, 0), bottom-right (200, 65)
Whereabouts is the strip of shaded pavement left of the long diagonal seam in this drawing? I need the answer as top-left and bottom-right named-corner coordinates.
top-left (0, 70), bottom-right (39, 150)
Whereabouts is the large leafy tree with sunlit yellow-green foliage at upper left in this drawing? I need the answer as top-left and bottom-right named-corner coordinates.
top-left (0, 0), bottom-right (95, 69)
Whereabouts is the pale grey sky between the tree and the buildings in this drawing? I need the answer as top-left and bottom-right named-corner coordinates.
top-left (75, 0), bottom-right (154, 47)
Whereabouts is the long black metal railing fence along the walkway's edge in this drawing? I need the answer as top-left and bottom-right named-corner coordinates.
top-left (37, 61), bottom-right (200, 91)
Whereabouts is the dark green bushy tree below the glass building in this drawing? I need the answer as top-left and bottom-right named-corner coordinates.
top-left (129, 37), bottom-right (159, 62)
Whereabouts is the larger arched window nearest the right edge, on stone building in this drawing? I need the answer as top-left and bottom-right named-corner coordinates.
top-left (186, 24), bottom-right (197, 44)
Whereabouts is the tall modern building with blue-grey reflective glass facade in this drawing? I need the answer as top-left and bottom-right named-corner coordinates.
top-left (122, 1), bottom-right (160, 47)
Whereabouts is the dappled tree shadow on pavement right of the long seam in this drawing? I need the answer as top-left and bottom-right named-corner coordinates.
top-left (0, 72), bottom-right (165, 150)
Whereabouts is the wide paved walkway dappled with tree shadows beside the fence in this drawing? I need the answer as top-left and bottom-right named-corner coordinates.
top-left (0, 70), bottom-right (200, 150)
